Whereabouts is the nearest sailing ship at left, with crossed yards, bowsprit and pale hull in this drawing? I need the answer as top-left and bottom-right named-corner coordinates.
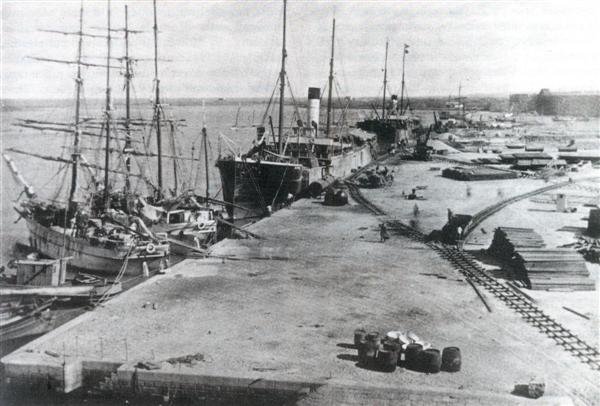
top-left (3, 3), bottom-right (169, 275)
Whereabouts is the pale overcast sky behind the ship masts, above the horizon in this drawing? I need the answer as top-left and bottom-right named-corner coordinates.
top-left (1, 0), bottom-right (600, 98)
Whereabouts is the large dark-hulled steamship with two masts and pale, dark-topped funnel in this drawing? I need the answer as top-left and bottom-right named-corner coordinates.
top-left (216, 0), bottom-right (376, 219)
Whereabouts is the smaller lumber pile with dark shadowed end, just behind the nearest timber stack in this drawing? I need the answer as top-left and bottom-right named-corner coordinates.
top-left (487, 227), bottom-right (546, 261)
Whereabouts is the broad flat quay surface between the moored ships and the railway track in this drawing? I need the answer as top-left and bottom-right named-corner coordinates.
top-left (1, 186), bottom-right (600, 405)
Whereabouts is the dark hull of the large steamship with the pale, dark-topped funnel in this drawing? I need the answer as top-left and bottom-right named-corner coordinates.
top-left (217, 144), bottom-right (374, 218)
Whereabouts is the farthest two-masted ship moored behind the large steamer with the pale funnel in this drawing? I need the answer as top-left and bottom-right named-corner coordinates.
top-left (356, 41), bottom-right (424, 150)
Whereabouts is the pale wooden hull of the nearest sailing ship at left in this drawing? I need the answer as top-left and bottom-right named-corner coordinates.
top-left (25, 218), bottom-right (167, 275)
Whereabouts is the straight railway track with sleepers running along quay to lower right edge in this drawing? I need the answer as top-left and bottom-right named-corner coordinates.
top-left (347, 182), bottom-right (600, 371)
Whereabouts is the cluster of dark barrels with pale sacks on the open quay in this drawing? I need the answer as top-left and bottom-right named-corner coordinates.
top-left (354, 329), bottom-right (461, 374)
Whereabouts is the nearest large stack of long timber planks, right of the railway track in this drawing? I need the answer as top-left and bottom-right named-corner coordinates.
top-left (513, 248), bottom-right (596, 290)
